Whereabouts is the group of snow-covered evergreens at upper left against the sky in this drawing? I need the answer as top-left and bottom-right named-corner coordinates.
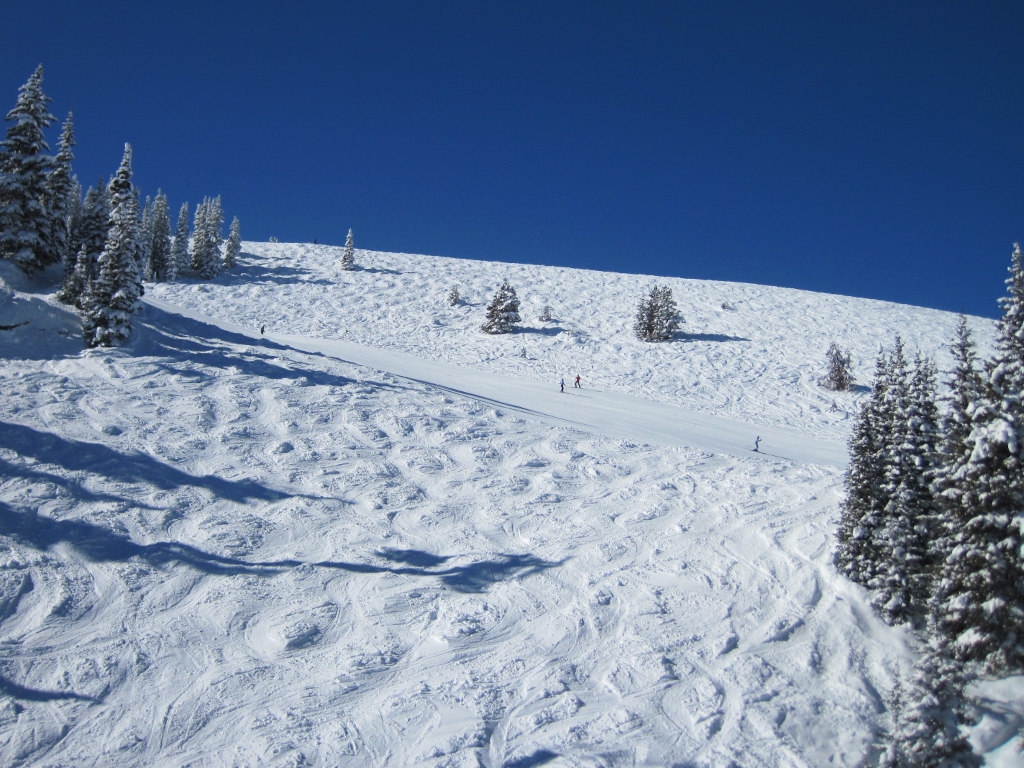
top-left (0, 66), bottom-right (242, 346)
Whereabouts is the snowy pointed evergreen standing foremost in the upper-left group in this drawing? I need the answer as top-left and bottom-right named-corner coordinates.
top-left (82, 144), bottom-right (142, 347)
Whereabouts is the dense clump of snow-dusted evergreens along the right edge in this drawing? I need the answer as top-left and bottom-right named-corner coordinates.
top-left (836, 245), bottom-right (1024, 766)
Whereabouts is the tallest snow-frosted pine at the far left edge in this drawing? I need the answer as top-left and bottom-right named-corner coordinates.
top-left (0, 65), bottom-right (54, 273)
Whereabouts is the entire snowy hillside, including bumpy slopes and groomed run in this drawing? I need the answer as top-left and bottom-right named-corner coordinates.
top-left (0, 243), bottom-right (1022, 768)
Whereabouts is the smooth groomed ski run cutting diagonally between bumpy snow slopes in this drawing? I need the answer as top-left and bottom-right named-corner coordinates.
top-left (143, 296), bottom-right (849, 468)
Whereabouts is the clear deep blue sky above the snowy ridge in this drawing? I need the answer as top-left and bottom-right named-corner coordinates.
top-left (0, 0), bottom-right (1024, 316)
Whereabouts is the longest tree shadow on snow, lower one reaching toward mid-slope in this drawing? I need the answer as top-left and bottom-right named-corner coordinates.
top-left (0, 502), bottom-right (564, 593)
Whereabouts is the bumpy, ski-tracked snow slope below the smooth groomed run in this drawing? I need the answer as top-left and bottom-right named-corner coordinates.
top-left (0, 286), bottom-right (909, 767)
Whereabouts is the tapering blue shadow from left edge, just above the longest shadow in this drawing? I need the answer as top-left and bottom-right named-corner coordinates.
top-left (0, 421), bottom-right (295, 506)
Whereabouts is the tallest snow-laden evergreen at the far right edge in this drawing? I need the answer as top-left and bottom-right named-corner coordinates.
top-left (936, 245), bottom-right (1024, 674)
